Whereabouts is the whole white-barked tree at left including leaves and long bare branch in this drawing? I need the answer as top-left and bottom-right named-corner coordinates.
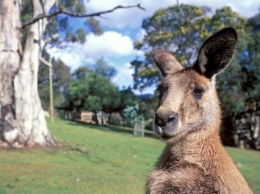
top-left (0, 0), bottom-right (144, 147)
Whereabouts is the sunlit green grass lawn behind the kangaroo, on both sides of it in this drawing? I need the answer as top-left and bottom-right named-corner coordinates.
top-left (0, 120), bottom-right (260, 194)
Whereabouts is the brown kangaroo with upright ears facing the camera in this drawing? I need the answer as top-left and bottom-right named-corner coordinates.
top-left (146, 28), bottom-right (253, 194)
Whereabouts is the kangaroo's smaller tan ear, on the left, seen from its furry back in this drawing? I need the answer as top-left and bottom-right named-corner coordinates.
top-left (153, 50), bottom-right (183, 76)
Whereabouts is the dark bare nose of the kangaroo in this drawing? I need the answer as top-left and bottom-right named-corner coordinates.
top-left (155, 111), bottom-right (178, 127)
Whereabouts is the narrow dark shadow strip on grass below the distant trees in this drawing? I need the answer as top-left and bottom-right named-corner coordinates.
top-left (66, 120), bottom-right (158, 139)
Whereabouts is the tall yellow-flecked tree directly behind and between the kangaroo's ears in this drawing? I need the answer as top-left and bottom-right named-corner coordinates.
top-left (131, 4), bottom-right (209, 90)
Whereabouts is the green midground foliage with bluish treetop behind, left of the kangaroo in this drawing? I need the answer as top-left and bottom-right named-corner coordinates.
top-left (63, 58), bottom-right (136, 118)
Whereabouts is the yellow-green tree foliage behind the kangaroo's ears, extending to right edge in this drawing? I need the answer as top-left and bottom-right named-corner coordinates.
top-left (131, 4), bottom-right (260, 115)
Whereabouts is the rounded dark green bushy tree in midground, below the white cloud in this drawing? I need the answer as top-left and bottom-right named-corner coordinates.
top-left (64, 68), bottom-right (120, 122)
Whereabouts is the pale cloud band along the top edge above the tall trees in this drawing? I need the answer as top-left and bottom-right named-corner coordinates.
top-left (85, 0), bottom-right (260, 29)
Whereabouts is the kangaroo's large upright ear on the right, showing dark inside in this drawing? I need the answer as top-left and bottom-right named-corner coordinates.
top-left (193, 28), bottom-right (237, 78)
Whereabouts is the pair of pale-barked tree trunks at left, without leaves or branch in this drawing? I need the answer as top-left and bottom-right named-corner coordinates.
top-left (0, 0), bottom-right (56, 147)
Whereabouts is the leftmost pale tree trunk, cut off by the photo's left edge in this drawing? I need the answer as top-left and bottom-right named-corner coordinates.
top-left (0, 0), bottom-right (21, 146)
